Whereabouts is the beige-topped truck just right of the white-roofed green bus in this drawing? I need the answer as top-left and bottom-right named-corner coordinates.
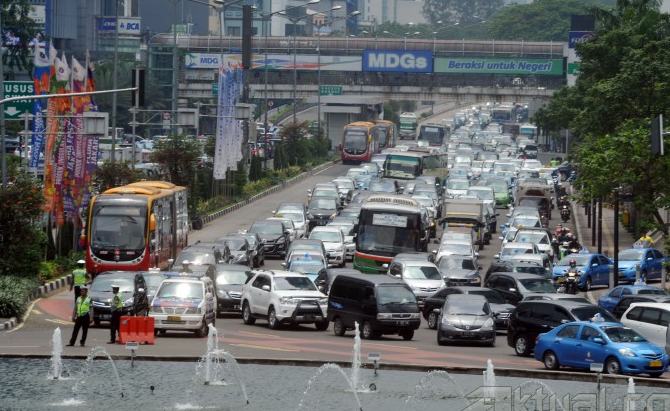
top-left (440, 198), bottom-right (491, 250)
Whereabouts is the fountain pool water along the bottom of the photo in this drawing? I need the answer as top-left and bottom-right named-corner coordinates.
top-left (0, 358), bottom-right (670, 411)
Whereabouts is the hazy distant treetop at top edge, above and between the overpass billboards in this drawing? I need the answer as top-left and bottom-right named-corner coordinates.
top-left (423, 0), bottom-right (504, 25)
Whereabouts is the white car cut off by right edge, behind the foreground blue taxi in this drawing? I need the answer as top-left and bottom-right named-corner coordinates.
top-left (621, 303), bottom-right (670, 347)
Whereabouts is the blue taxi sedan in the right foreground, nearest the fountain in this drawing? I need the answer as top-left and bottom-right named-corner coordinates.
top-left (535, 321), bottom-right (668, 377)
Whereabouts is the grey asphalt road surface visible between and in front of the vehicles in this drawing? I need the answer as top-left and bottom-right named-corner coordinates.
top-left (0, 155), bottom-right (584, 376)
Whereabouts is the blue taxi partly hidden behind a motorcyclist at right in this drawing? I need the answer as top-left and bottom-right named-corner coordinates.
top-left (552, 253), bottom-right (612, 291)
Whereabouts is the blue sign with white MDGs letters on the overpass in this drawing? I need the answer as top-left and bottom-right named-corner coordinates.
top-left (363, 50), bottom-right (433, 73)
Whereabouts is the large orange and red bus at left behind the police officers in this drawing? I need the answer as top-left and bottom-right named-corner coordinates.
top-left (82, 181), bottom-right (189, 275)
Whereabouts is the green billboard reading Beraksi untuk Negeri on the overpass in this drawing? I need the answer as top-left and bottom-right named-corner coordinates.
top-left (435, 57), bottom-right (563, 76)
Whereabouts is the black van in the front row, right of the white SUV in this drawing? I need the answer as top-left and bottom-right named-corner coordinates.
top-left (328, 274), bottom-right (421, 340)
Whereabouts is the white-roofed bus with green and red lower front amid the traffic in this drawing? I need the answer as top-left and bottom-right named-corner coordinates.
top-left (354, 194), bottom-right (424, 274)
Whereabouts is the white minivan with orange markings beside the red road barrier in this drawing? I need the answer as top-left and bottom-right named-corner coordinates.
top-left (149, 272), bottom-right (217, 337)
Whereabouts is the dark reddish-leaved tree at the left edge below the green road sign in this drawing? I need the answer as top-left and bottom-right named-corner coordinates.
top-left (0, 168), bottom-right (46, 278)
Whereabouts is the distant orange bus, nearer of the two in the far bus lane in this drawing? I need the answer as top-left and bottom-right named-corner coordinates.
top-left (341, 121), bottom-right (386, 164)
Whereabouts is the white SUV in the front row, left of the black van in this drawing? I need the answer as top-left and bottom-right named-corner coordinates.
top-left (242, 271), bottom-right (328, 331)
